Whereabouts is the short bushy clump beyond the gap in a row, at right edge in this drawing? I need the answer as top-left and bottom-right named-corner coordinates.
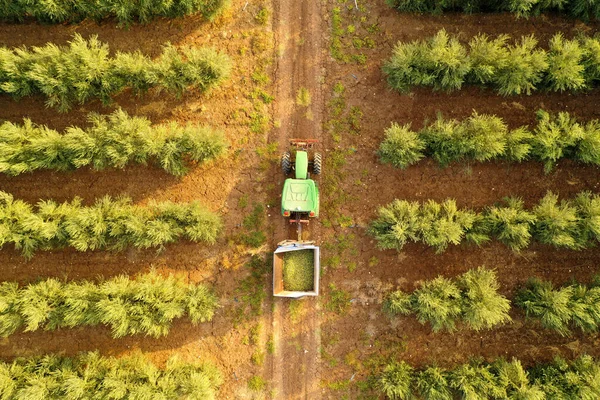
top-left (515, 279), bottom-right (600, 336)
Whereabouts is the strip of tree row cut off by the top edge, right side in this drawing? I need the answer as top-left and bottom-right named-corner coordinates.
top-left (386, 0), bottom-right (600, 20)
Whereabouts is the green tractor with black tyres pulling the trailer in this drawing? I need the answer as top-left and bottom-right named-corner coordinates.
top-left (281, 139), bottom-right (323, 240)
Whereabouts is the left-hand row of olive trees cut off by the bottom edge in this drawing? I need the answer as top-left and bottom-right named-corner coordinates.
top-left (0, 352), bottom-right (223, 400)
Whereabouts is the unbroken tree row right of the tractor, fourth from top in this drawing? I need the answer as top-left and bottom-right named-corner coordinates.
top-left (369, 192), bottom-right (600, 253)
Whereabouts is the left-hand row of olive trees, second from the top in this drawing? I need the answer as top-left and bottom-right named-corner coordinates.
top-left (0, 34), bottom-right (231, 111)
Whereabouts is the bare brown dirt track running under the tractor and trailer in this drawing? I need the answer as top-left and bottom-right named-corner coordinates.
top-left (269, 0), bottom-right (326, 400)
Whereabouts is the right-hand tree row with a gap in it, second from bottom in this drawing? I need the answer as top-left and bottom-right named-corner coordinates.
top-left (383, 268), bottom-right (600, 336)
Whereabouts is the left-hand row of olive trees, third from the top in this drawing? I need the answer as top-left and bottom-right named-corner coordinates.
top-left (0, 110), bottom-right (226, 176)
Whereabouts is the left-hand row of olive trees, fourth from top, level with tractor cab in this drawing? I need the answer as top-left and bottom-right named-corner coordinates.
top-left (0, 192), bottom-right (222, 257)
